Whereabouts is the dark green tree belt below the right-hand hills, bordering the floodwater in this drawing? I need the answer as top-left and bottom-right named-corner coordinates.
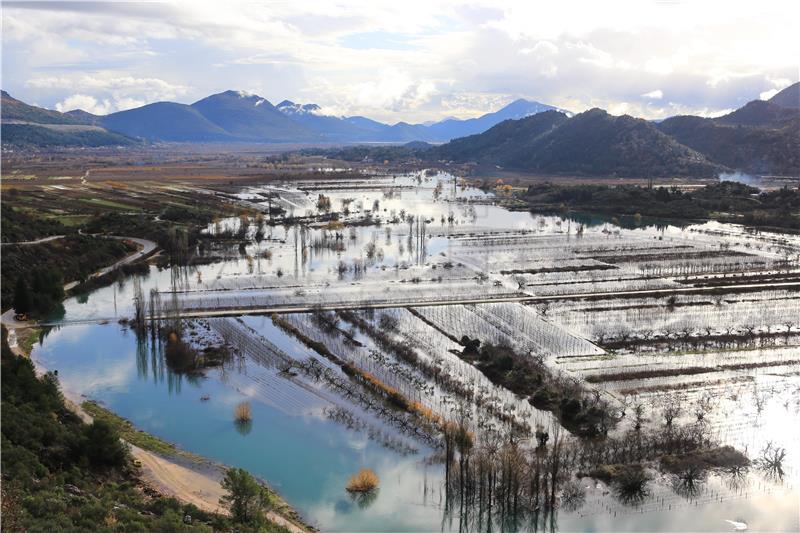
top-left (522, 181), bottom-right (800, 229)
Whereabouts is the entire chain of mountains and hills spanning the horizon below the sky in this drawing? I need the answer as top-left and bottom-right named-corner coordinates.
top-left (2, 83), bottom-right (800, 176)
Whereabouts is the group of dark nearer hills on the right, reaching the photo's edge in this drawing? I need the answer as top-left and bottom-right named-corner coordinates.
top-left (432, 83), bottom-right (800, 176)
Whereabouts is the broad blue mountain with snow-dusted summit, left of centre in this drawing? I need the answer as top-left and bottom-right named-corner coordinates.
top-left (191, 91), bottom-right (312, 142)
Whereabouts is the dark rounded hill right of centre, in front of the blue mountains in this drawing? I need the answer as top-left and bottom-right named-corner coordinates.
top-left (433, 109), bottom-right (724, 177)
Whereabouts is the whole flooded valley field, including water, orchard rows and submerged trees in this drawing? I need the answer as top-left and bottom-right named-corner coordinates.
top-left (33, 173), bottom-right (800, 531)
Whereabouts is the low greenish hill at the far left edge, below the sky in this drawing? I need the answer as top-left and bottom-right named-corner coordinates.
top-left (0, 91), bottom-right (135, 147)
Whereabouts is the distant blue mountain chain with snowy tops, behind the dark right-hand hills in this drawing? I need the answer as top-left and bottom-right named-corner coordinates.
top-left (3, 91), bottom-right (556, 143)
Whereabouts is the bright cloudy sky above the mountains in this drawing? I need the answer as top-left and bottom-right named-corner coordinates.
top-left (2, 0), bottom-right (800, 123)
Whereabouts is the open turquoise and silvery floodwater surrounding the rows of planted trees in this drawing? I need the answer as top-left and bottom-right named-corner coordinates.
top-left (33, 172), bottom-right (800, 531)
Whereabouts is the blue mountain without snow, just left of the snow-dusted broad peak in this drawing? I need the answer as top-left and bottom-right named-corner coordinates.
top-left (100, 102), bottom-right (231, 142)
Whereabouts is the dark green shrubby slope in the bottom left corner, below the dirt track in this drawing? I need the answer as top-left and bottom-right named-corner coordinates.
top-left (2, 329), bottom-right (294, 533)
